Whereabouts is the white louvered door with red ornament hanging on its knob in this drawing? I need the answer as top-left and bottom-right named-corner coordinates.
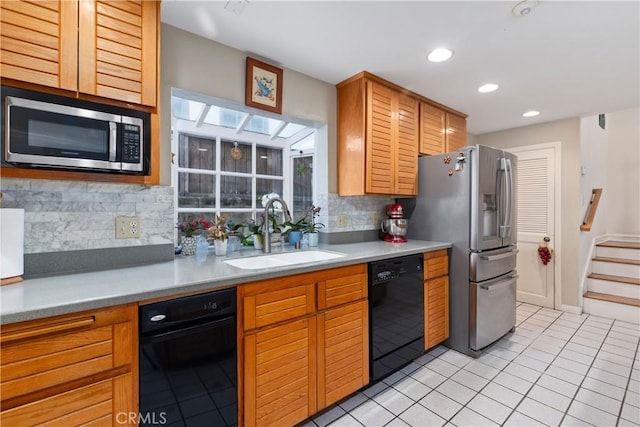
top-left (507, 144), bottom-right (559, 308)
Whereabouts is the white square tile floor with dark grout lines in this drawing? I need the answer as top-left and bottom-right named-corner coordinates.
top-left (302, 303), bottom-right (640, 427)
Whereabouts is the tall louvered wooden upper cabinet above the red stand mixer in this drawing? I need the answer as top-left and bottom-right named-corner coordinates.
top-left (337, 72), bottom-right (419, 196)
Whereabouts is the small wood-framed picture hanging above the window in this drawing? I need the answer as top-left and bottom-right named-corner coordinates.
top-left (245, 57), bottom-right (283, 114)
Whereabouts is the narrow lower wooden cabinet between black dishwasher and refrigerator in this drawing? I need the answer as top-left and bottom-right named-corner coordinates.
top-left (424, 249), bottom-right (449, 350)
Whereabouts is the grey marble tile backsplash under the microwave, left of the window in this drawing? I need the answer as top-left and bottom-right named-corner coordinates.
top-left (0, 178), bottom-right (175, 254)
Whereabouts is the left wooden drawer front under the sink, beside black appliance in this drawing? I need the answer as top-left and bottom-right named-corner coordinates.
top-left (242, 283), bottom-right (315, 331)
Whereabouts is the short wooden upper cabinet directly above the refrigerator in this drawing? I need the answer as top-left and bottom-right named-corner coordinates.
top-left (420, 102), bottom-right (467, 155)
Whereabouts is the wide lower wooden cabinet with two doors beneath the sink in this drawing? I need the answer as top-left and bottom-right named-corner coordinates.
top-left (238, 264), bottom-right (369, 426)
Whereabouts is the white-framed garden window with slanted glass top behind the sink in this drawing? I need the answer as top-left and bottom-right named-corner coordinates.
top-left (171, 89), bottom-right (316, 234)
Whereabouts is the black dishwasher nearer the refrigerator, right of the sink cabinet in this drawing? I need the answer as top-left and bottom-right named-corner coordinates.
top-left (369, 254), bottom-right (424, 382)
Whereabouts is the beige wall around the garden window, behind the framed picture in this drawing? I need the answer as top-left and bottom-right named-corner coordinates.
top-left (160, 24), bottom-right (337, 192)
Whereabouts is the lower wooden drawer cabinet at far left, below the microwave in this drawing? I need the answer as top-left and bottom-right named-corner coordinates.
top-left (0, 305), bottom-right (138, 427)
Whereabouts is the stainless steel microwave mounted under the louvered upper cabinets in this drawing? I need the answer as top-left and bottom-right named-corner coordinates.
top-left (2, 86), bottom-right (150, 175)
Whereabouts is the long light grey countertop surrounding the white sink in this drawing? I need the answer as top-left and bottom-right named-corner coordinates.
top-left (0, 240), bottom-right (451, 324)
